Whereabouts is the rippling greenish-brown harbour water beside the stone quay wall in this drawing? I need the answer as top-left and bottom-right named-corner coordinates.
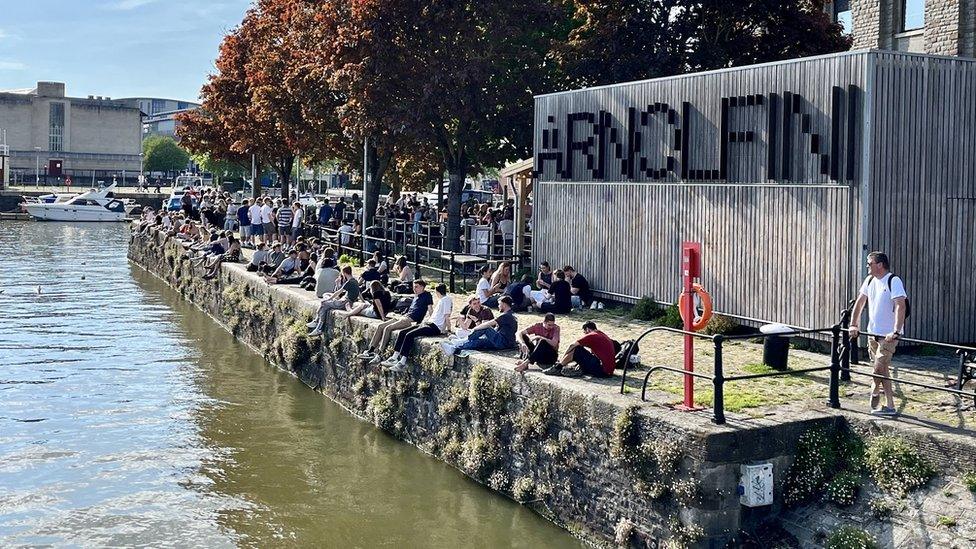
top-left (0, 221), bottom-right (579, 547)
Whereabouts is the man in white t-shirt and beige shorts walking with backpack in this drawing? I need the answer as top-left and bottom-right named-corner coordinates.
top-left (850, 252), bottom-right (908, 416)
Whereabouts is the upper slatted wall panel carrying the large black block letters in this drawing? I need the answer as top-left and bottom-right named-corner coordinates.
top-left (535, 62), bottom-right (863, 183)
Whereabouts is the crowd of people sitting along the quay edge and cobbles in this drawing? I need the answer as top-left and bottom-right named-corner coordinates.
top-left (137, 206), bottom-right (616, 377)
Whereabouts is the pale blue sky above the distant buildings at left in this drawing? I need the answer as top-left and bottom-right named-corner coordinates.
top-left (0, 0), bottom-right (251, 101)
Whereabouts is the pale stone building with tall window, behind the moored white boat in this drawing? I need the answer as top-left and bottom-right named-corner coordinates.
top-left (0, 82), bottom-right (142, 185)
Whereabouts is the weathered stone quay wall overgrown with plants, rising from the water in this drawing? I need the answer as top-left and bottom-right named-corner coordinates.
top-left (129, 235), bottom-right (842, 547)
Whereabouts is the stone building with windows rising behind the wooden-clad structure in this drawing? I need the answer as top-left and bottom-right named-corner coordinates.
top-left (828, 0), bottom-right (976, 57)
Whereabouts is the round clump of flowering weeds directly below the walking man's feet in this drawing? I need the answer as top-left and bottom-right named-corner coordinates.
top-left (865, 435), bottom-right (935, 496)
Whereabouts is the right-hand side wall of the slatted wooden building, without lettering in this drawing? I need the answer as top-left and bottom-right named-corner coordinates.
top-left (867, 52), bottom-right (976, 342)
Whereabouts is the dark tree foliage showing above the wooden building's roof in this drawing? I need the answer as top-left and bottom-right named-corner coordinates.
top-left (553, 0), bottom-right (851, 87)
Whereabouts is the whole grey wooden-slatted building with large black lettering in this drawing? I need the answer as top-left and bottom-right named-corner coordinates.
top-left (533, 51), bottom-right (976, 342)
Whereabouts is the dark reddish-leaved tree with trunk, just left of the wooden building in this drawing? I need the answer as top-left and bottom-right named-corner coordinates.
top-left (328, 0), bottom-right (561, 249)
